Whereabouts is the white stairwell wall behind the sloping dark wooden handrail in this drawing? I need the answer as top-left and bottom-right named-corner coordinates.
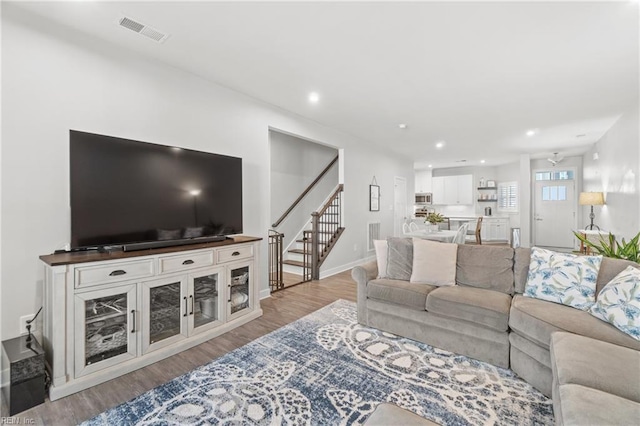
top-left (269, 131), bottom-right (338, 248)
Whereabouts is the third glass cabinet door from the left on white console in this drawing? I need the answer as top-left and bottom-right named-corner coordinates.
top-left (189, 268), bottom-right (222, 332)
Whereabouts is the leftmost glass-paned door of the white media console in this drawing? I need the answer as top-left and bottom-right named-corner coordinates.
top-left (75, 285), bottom-right (137, 376)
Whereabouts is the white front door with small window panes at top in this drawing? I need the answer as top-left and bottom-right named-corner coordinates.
top-left (533, 170), bottom-right (576, 248)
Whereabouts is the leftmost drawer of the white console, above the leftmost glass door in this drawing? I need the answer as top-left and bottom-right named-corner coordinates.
top-left (75, 259), bottom-right (154, 288)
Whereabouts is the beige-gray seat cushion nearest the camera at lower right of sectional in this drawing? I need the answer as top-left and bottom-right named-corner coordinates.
top-left (551, 333), bottom-right (640, 402)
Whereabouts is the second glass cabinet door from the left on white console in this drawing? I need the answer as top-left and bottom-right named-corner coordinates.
top-left (142, 278), bottom-right (186, 353)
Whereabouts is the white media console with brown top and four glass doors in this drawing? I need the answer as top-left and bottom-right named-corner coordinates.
top-left (40, 236), bottom-right (262, 401)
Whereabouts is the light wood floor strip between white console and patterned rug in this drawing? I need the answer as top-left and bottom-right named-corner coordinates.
top-left (11, 271), bottom-right (356, 425)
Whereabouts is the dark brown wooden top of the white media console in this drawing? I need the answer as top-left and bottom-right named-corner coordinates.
top-left (40, 235), bottom-right (262, 266)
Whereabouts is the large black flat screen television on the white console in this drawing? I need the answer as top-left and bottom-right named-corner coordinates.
top-left (69, 130), bottom-right (242, 250)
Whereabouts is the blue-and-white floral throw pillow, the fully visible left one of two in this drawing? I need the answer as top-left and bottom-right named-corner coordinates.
top-left (524, 247), bottom-right (602, 311)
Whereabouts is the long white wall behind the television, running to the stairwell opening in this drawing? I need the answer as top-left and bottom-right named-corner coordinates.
top-left (0, 3), bottom-right (413, 339)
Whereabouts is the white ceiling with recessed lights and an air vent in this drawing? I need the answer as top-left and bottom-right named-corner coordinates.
top-left (10, 1), bottom-right (639, 168)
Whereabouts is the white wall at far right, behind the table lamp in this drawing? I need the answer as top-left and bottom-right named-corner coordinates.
top-left (582, 105), bottom-right (640, 240)
